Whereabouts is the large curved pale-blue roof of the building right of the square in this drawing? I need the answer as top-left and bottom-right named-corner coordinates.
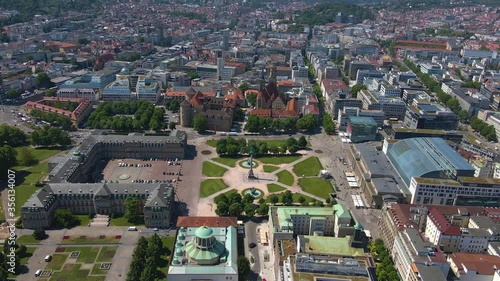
top-left (383, 138), bottom-right (475, 187)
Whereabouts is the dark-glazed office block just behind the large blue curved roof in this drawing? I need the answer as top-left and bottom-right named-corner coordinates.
top-left (404, 99), bottom-right (458, 131)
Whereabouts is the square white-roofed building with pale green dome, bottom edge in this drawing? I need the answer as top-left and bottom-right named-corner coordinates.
top-left (167, 225), bottom-right (238, 281)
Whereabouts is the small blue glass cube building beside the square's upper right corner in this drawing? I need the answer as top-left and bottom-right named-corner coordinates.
top-left (347, 116), bottom-right (378, 143)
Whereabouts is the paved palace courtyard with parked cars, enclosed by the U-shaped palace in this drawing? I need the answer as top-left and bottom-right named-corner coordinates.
top-left (103, 158), bottom-right (182, 184)
